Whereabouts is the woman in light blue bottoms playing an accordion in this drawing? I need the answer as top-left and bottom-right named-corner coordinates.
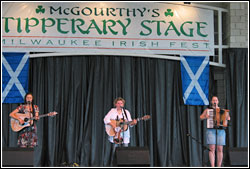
top-left (200, 96), bottom-right (230, 167)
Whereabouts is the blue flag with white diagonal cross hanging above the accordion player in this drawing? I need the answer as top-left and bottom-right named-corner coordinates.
top-left (180, 56), bottom-right (209, 105)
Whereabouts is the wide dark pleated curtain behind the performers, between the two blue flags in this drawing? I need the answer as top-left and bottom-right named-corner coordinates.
top-left (2, 50), bottom-right (247, 166)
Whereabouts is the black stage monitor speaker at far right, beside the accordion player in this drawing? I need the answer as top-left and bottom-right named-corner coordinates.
top-left (229, 147), bottom-right (248, 166)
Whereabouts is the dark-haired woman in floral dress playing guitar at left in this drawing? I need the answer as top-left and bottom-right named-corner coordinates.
top-left (9, 93), bottom-right (39, 147)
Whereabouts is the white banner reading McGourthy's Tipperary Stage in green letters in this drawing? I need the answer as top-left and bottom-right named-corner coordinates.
top-left (2, 1), bottom-right (214, 56)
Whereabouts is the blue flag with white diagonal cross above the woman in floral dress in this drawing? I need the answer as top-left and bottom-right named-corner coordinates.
top-left (2, 52), bottom-right (29, 103)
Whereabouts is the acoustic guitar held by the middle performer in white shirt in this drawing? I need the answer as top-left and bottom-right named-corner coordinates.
top-left (105, 115), bottom-right (150, 136)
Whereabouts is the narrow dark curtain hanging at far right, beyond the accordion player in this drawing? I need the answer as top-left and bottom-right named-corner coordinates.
top-left (225, 48), bottom-right (249, 147)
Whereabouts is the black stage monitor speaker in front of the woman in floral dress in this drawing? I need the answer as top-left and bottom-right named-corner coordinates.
top-left (2, 147), bottom-right (34, 167)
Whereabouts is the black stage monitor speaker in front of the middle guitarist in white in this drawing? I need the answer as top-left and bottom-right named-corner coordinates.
top-left (114, 147), bottom-right (150, 167)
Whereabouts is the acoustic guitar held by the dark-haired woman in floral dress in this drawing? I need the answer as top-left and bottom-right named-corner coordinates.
top-left (10, 111), bottom-right (57, 132)
